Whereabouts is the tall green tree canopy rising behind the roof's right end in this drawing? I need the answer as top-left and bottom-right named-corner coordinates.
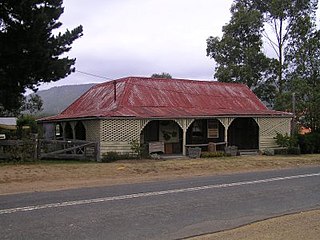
top-left (207, 0), bottom-right (320, 131)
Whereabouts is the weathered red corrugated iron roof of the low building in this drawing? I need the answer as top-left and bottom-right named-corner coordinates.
top-left (42, 77), bottom-right (291, 121)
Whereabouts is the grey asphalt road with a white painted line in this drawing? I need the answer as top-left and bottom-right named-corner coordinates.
top-left (0, 166), bottom-right (320, 240)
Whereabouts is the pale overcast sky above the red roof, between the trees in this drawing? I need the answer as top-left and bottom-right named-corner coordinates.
top-left (40, 0), bottom-right (232, 90)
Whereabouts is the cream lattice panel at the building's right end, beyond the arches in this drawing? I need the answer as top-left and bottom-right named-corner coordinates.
top-left (259, 118), bottom-right (291, 136)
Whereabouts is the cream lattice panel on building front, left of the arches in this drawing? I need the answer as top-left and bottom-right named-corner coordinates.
top-left (101, 119), bottom-right (140, 142)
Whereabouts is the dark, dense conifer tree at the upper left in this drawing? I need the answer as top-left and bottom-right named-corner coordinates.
top-left (0, 0), bottom-right (82, 112)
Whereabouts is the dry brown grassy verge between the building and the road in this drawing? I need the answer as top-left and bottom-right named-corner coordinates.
top-left (0, 155), bottom-right (320, 194)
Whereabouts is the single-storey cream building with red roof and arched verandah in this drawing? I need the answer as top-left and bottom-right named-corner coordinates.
top-left (40, 77), bottom-right (292, 155)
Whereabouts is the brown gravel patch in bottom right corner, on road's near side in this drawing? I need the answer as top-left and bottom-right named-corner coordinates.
top-left (190, 210), bottom-right (320, 240)
